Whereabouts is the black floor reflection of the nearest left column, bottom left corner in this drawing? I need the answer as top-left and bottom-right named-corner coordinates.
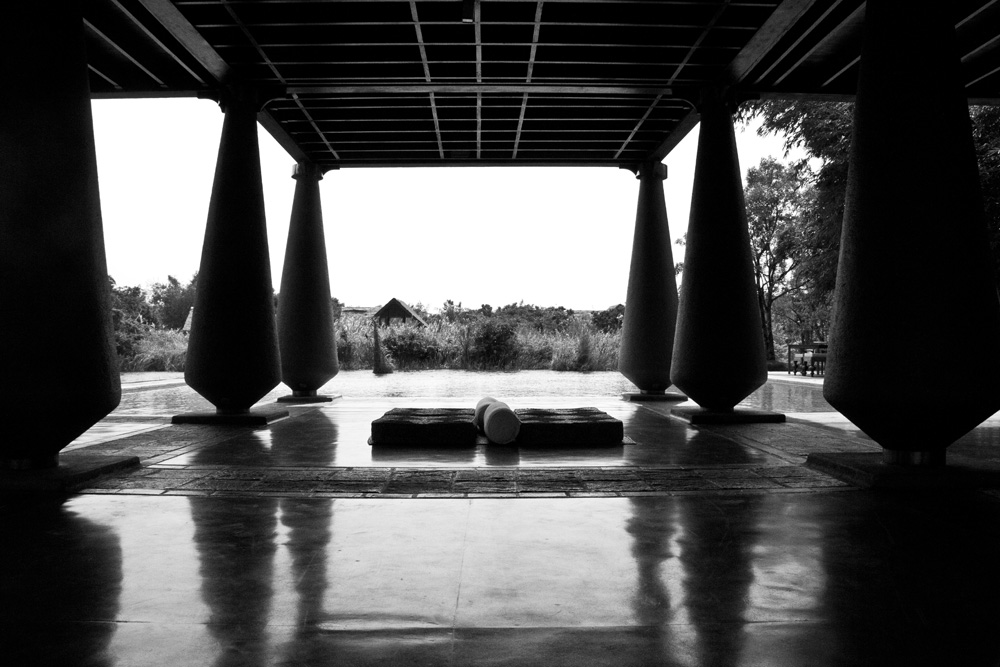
top-left (0, 503), bottom-right (122, 667)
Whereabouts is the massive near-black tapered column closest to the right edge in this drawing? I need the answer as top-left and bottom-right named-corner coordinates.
top-left (823, 0), bottom-right (1000, 463)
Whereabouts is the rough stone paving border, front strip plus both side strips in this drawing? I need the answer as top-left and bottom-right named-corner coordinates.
top-left (64, 407), bottom-right (878, 498)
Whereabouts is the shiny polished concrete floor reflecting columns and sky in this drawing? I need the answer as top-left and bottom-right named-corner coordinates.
top-left (0, 379), bottom-right (1000, 667)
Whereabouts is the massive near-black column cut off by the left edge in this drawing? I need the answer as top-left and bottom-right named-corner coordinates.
top-left (0, 0), bottom-right (121, 468)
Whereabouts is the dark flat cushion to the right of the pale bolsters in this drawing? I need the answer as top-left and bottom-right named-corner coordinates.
top-left (514, 408), bottom-right (625, 447)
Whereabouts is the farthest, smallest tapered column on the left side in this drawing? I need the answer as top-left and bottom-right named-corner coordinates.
top-left (278, 164), bottom-right (340, 402)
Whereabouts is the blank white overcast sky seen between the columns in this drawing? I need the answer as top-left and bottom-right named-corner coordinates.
top-left (93, 99), bottom-right (796, 312)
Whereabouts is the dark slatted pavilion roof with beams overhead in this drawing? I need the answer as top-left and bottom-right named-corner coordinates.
top-left (85, 0), bottom-right (1000, 168)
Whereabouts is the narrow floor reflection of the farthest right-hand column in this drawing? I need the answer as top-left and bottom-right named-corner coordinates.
top-left (625, 498), bottom-right (677, 665)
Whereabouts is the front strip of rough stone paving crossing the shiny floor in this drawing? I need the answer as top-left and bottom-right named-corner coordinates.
top-left (84, 465), bottom-right (849, 498)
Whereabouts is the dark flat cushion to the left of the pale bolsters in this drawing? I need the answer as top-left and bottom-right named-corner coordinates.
top-left (370, 408), bottom-right (479, 447)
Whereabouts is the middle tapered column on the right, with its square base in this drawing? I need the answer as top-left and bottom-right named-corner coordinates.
top-left (671, 95), bottom-right (784, 421)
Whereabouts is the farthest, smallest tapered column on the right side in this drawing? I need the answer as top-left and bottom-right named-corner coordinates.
top-left (618, 163), bottom-right (677, 396)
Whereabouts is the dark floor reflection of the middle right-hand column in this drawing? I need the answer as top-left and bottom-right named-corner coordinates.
top-left (678, 495), bottom-right (762, 666)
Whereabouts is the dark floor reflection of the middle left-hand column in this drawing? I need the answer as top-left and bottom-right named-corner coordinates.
top-left (189, 440), bottom-right (278, 667)
